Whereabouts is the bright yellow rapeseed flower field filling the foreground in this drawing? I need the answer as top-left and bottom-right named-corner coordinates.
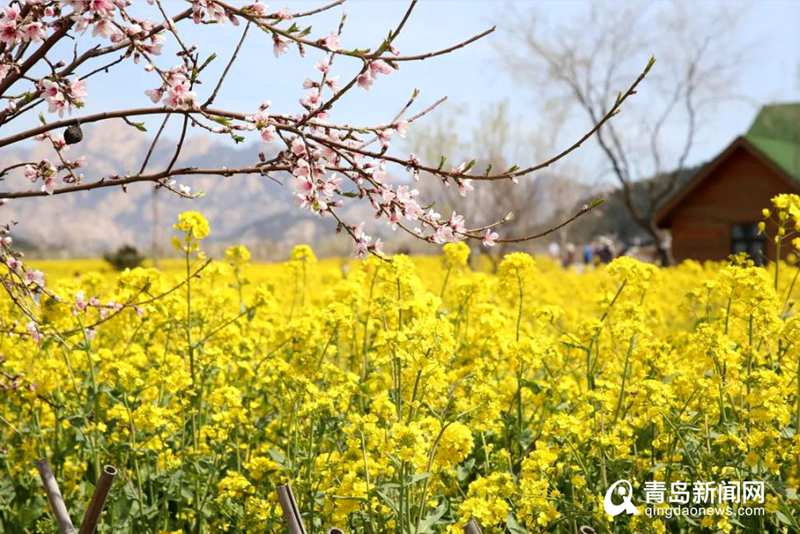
top-left (0, 202), bottom-right (800, 533)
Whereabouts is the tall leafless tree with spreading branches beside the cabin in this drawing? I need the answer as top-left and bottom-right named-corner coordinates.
top-left (499, 3), bottom-right (740, 264)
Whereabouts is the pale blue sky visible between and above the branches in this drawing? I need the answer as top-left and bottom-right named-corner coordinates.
top-left (10, 0), bottom-right (800, 182)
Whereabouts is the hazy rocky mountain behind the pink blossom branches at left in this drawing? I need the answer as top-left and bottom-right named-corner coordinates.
top-left (0, 122), bottom-right (360, 257)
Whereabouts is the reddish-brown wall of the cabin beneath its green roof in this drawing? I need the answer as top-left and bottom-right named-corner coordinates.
top-left (668, 147), bottom-right (797, 261)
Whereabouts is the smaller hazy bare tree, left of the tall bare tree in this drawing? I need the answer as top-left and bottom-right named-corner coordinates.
top-left (409, 100), bottom-right (582, 263)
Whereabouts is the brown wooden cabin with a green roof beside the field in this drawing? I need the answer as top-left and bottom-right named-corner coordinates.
top-left (655, 103), bottom-right (800, 263)
